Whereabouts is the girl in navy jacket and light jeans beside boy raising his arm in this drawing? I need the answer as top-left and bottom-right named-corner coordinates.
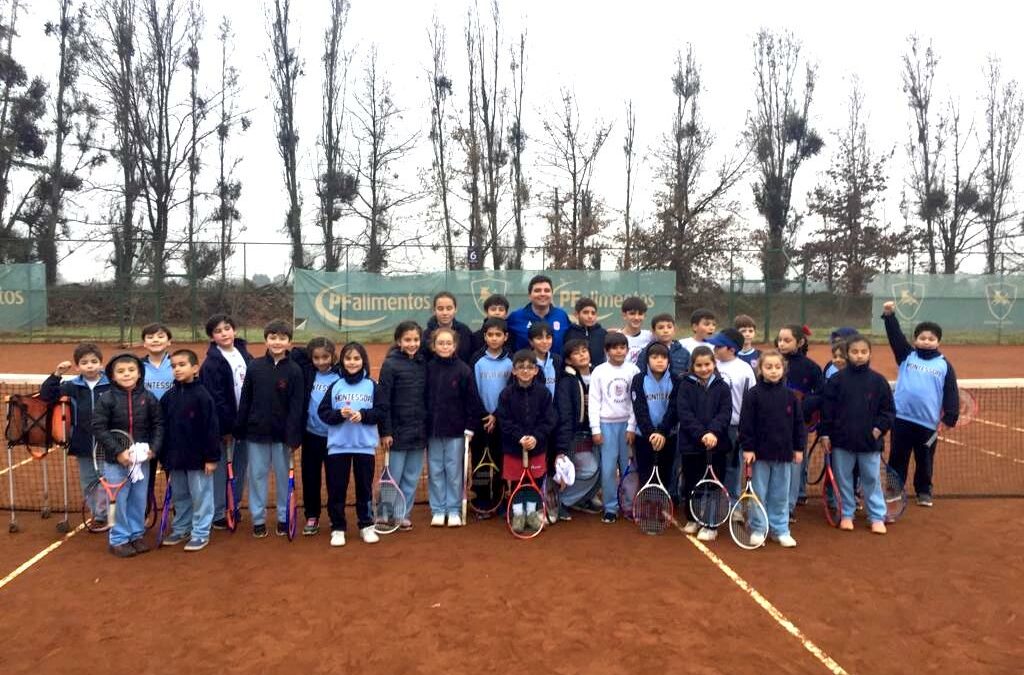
top-left (819, 335), bottom-right (895, 535)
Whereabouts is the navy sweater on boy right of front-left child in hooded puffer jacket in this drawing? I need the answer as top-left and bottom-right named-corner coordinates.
top-left (158, 380), bottom-right (220, 471)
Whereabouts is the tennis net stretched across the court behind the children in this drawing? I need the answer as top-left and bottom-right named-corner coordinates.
top-left (0, 375), bottom-right (1024, 511)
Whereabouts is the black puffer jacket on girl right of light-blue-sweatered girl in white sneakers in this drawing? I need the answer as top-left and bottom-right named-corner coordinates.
top-left (374, 347), bottom-right (427, 451)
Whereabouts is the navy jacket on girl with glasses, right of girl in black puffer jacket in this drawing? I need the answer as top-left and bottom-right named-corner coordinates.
top-left (427, 354), bottom-right (483, 438)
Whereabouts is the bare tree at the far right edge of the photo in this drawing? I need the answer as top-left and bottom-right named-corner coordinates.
top-left (978, 56), bottom-right (1024, 275)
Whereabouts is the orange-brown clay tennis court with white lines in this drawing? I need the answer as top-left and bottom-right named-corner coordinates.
top-left (0, 345), bottom-right (1024, 673)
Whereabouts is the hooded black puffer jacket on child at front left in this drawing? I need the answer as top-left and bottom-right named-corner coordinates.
top-left (92, 353), bottom-right (164, 464)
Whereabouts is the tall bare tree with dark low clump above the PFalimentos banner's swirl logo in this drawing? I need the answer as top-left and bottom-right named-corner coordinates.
top-left (316, 0), bottom-right (357, 271)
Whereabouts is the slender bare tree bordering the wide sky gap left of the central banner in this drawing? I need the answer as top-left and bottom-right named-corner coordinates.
top-left (210, 16), bottom-right (250, 294)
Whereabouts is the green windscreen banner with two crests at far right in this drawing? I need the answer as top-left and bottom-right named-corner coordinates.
top-left (868, 275), bottom-right (1024, 333)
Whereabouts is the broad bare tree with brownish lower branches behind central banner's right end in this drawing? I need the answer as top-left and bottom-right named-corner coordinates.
top-left (634, 46), bottom-right (751, 315)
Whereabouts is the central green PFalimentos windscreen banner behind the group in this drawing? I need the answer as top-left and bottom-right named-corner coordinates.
top-left (294, 269), bottom-right (675, 336)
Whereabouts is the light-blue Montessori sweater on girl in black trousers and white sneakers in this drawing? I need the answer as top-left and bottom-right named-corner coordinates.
top-left (316, 372), bottom-right (380, 455)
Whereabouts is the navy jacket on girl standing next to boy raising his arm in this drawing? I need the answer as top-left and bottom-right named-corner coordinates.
top-left (818, 364), bottom-right (895, 453)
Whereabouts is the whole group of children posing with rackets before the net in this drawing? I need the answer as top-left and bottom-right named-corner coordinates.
top-left (41, 276), bottom-right (958, 557)
